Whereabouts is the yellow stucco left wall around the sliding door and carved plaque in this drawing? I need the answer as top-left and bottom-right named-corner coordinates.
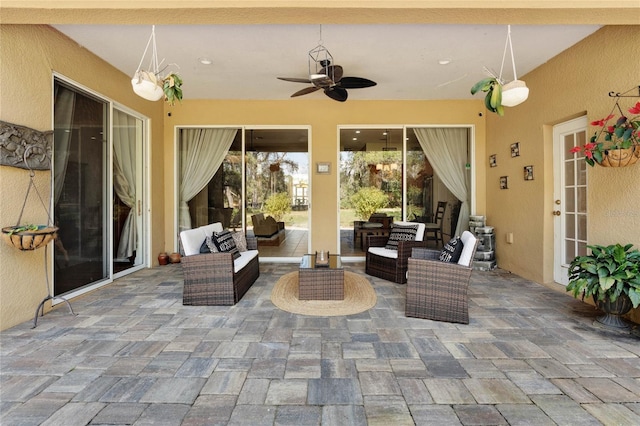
top-left (0, 25), bottom-right (164, 329)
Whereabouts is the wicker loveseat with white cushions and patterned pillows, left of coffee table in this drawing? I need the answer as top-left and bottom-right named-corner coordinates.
top-left (180, 222), bottom-right (260, 305)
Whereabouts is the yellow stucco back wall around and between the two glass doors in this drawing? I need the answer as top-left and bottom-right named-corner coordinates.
top-left (165, 98), bottom-right (486, 251)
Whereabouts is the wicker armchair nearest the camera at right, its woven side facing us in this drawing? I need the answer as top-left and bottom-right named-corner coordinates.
top-left (405, 231), bottom-right (478, 324)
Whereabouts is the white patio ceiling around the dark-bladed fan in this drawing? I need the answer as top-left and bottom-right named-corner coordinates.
top-left (54, 24), bottom-right (600, 100)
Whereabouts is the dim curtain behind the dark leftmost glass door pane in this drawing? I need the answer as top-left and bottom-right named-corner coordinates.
top-left (53, 84), bottom-right (76, 205)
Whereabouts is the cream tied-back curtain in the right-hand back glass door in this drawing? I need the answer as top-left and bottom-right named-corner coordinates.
top-left (413, 128), bottom-right (470, 235)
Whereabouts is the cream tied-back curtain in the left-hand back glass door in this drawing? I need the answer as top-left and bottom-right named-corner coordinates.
top-left (179, 129), bottom-right (238, 231)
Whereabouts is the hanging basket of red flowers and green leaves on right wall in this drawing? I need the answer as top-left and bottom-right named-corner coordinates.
top-left (570, 102), bottom-right (640, 167)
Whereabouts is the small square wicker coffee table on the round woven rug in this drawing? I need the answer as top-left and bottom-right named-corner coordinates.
top-left (298, 254), bottom-right (344, 300)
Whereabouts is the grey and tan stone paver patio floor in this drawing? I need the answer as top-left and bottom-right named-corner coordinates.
top-left (0, 263), bottom-right (640, 426)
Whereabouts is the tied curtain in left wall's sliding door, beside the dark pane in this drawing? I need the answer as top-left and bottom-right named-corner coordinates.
top-left (113, 109), bottom-right (139, 260)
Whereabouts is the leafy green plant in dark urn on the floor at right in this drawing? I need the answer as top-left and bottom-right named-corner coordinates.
top-left (566, 244), bottom-right (640, 328)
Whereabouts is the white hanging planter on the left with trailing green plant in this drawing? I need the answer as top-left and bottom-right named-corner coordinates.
top-left (131, 25), bottom-right (182, 105)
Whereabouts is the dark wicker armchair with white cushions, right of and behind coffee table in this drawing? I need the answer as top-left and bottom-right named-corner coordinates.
top-left (364, 222), bottom-right (426, 284)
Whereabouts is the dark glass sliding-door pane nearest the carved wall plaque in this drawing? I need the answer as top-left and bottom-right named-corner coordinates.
top-left (53, 81), bottom-right (111, 295)
